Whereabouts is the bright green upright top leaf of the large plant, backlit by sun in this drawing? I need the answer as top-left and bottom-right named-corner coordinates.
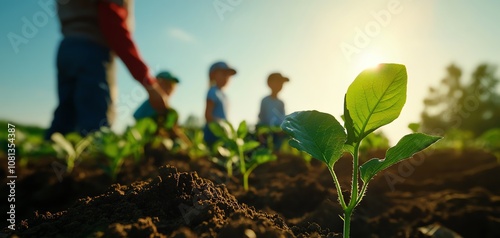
top-left (344, 64), bottom-right (408, 142)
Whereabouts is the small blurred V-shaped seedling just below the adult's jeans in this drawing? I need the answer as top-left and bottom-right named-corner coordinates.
top-left (50, 132), bottom-right (93, 173)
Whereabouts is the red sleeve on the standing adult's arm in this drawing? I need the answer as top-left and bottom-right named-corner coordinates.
top-left (98, 1), bottom-right (156, 86)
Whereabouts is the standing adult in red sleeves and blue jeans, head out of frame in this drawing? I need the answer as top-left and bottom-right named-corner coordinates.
top-left (45, 0), bottom-right (168, 139)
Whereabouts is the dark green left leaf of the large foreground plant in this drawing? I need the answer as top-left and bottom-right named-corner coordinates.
top-left (281, 111), bottom-right (346, 166)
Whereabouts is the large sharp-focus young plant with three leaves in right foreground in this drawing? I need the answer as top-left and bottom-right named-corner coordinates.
top-left (281, 64), bottom-right (440, 237)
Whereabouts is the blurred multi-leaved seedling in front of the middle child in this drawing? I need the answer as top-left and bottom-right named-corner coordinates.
top-left (208, 120), bottom-right (260, 176)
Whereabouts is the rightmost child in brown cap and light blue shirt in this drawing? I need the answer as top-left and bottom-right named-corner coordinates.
top-left (257, 73), bottom-right (290, 150)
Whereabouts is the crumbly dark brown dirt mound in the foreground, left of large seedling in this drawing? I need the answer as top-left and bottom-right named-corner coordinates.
top-left (13, 166), bottom-right (318, 237)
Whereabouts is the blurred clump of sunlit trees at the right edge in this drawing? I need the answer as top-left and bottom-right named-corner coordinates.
top-left (421, 64), bottom-right (500, 136)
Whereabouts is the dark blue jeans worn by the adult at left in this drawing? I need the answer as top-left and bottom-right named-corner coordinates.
top-left (45, 37), bottom-right (116, 139)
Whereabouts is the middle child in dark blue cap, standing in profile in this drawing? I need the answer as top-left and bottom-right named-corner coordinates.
top-left (203, 62), bottom-right (236, 146)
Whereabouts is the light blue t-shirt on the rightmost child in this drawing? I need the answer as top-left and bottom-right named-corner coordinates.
top-left (259, 96), bottom-right (285, 126)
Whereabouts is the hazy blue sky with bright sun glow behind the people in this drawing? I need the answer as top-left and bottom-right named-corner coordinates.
top-left (0, 0), bottom-right (500, 144)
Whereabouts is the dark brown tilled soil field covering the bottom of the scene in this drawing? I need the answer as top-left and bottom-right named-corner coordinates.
top-left (0, 148), bottom-right (500, 237)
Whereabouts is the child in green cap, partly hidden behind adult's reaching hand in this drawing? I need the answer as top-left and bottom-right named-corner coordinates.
top-left (134, 71), bottom-right (190, 145)
